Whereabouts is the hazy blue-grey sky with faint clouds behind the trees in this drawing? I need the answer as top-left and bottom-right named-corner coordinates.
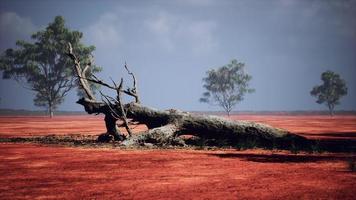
top-left (0, 0), bottom-right (356, 110)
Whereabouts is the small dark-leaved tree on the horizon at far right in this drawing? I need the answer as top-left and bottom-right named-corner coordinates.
top-left (310, 71), bottom-right (347, 115)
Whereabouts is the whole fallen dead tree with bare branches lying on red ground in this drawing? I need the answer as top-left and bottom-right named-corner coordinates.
top-left (68, 44), bottom-right (309, 148)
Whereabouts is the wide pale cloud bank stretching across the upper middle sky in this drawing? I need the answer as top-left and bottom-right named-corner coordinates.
top-left (84, 6), bottom-right (218, 55)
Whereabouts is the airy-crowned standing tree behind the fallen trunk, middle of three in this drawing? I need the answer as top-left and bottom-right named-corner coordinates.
top-left (200, 60), bottom-right (255, 116)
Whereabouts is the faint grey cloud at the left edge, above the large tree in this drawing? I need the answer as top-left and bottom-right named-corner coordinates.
top-left (0, 12), bottom-right (36, 48)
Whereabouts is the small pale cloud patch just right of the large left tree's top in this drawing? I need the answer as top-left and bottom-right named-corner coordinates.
top-left (84, 13), bottom-right (122, 49)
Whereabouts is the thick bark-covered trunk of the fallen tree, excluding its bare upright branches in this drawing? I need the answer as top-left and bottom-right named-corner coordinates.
top-left (78, 99), bottom-right (310, 149)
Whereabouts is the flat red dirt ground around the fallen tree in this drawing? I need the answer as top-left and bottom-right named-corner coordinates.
top-left (0, 115), bottom-right (356, 199)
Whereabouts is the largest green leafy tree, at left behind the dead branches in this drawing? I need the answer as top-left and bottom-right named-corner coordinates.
top-left (0, 16), bottom-right (101, 117)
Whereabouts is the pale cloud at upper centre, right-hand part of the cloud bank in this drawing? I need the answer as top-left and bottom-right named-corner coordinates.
top-left (145, 12), bottom-right (218, 54)
